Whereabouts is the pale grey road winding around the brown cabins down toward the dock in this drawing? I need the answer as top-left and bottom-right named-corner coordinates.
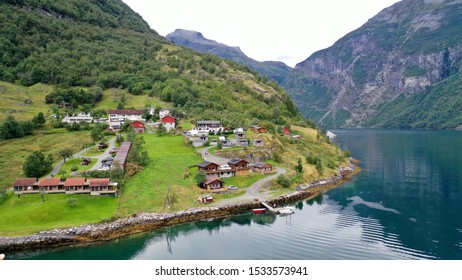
top-left (200, 147), bottom-right (287, 206)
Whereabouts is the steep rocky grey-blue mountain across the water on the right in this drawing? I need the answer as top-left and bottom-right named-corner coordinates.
top-left (283, 0), bottom-right (462, 129)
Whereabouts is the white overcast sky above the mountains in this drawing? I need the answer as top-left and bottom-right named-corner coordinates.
top-left (123, 0), bottom-right (398, 67)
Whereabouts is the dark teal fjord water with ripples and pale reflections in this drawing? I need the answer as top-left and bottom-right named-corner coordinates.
top-left (15, 129), bottom-right (462, 260)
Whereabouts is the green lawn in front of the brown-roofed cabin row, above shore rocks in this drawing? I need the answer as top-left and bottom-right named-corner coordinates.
top-left (0, 190), bottom-right (118, 236)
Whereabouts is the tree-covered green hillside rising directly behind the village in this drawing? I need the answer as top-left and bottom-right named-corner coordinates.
top-left (0, 0), bottom-right (303, 127)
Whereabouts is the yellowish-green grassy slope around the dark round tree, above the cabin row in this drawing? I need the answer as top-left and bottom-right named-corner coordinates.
top-left (0, 129), bottom-right (91, 189)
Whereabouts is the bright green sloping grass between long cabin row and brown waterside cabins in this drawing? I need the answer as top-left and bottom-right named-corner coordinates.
top-left (116, 135), bottom-right (201, 216)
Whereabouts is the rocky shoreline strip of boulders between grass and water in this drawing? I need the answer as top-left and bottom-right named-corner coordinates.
top-left (0, 164), bottom-right (360, 254)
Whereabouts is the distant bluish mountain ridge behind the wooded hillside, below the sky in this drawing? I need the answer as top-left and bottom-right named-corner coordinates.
top-left (166, 29), bottom-right (292, 83)
